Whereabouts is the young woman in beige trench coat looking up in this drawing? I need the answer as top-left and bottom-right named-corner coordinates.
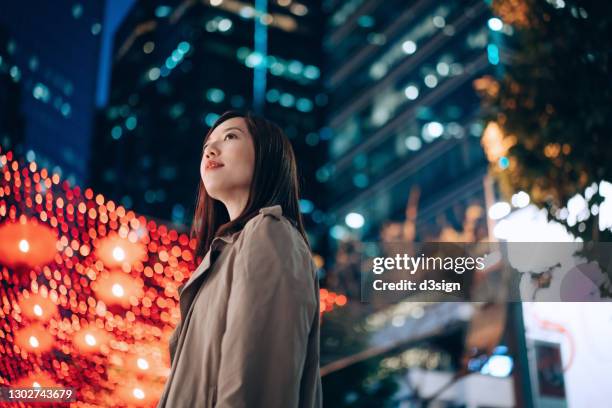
top-left (158, 111), bottom-right (322, 408)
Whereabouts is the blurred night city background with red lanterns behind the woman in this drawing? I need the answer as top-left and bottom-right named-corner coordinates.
top-left (0, 0), bottom-right (612, 407)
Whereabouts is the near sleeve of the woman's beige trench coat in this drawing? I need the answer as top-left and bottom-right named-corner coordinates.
top-left (217, 216), bottom-right (318, 408)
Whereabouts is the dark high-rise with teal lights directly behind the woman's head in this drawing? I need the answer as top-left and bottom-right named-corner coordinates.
top-left (91, 0), bottom-right (327, 245)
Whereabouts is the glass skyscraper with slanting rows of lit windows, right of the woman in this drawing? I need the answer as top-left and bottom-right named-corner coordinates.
top-left (317, 0), bottom-right (508, 240)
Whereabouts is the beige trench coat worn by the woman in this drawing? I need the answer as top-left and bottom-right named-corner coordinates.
top-left (158, 205), bottom-right (322, 408)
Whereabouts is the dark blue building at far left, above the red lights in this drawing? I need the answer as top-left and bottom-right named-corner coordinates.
top-left (0, 0), bottom-right (104, 184)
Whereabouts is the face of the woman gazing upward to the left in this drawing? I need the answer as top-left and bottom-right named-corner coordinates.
top-left (200, 117), bottom-right (255, 205)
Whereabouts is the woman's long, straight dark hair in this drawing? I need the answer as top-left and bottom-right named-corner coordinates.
top-left (191, 111), bottom-right (310, 258)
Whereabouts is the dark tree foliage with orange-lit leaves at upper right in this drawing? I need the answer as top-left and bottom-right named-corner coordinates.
top-left (477, 0), bottom-right (612, 240)
